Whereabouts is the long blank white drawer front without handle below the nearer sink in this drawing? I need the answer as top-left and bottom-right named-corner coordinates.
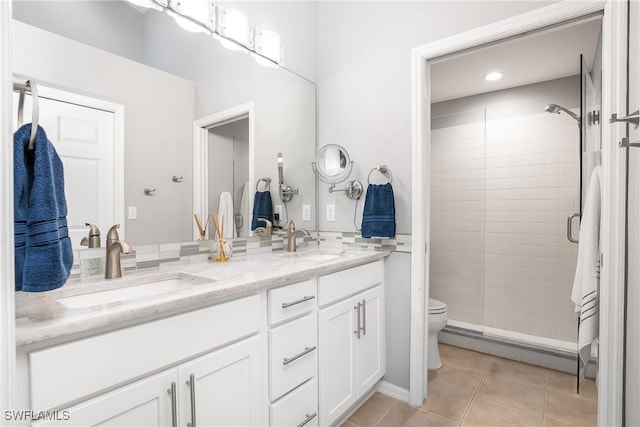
top-left (29, 295), bottom-right (260, 410)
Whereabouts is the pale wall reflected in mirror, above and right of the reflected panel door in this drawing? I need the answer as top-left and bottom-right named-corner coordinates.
top-left (13, 21), bottom-right (194, 244)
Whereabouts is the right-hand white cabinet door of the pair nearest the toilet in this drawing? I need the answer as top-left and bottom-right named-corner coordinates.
top-left (356, 286), bottom-right (385, 397)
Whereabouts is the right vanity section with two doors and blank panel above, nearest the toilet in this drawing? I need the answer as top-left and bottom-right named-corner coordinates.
top-left (318, 261), bottom-right (385, 425)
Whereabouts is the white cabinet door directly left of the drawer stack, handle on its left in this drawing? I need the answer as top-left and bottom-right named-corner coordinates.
top-left (178, 336), bottom-right (267, 426)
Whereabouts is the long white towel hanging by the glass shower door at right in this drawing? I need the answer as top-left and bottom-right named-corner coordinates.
top-left (571, 166), bottom-right (602, 364)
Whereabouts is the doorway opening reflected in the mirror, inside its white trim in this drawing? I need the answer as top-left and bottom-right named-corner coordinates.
top-left (208, 118), bottom-right (252, 238)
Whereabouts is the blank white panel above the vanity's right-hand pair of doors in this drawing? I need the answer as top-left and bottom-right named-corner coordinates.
top-left (318, 261), bottom-right (384, 306)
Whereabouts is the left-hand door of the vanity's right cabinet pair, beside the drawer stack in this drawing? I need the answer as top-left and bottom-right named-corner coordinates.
top-left (318, 298), bottom-right (357, 425)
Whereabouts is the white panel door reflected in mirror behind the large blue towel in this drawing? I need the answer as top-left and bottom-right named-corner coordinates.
top-left (14, 93), bottom-right (116, 249)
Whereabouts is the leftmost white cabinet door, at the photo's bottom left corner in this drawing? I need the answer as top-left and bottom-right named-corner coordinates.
top-left (33, 369), bottom-right (177, 427)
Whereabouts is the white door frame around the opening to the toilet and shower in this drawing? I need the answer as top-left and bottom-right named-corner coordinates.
top-left (409, 0), bottom-right (626, 425)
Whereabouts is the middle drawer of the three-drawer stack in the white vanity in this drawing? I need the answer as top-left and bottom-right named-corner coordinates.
top-left (269, 313), bottom-right (318, 401)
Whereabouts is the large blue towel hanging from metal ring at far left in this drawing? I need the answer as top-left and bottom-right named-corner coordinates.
top-left (13, 124), bottom-right (73, 292)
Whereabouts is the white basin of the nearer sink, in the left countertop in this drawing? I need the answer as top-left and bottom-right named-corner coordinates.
top-left (58, 273), bottom-right (214, 308)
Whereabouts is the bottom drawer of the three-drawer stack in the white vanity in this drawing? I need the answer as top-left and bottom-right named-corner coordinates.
top-left (269, 378), bottom-right (318, 427)
